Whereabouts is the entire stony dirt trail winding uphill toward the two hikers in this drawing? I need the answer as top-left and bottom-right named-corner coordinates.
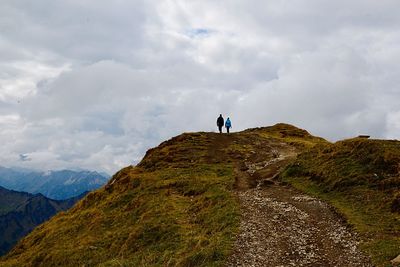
top-left (211, 137), bottom-right (372, 267)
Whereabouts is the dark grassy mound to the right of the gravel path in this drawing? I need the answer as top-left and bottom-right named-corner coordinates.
top-left (282, 138), bottom-right (400, 266)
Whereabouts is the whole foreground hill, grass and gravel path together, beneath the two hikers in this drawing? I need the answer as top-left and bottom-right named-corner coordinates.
top-left (0, 124), bottom-right (400, 266)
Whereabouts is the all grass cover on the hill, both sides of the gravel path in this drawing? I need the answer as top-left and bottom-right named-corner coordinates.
top-left (0, 124), bottom-right (399, 266)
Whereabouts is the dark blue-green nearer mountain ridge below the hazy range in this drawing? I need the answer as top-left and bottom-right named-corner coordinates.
top-left (0, 186), bottom-right (87, 255)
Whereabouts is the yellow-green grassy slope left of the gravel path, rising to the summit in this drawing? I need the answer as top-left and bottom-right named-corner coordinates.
top-left (0, 124), bottom-right (323, 266)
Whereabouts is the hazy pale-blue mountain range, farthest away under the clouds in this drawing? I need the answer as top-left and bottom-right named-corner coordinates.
top-left (0, 166), bottom-right (109, 200)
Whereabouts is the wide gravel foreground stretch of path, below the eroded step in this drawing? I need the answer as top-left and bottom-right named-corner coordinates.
top-left (228, 185), bottom-right (372, 266)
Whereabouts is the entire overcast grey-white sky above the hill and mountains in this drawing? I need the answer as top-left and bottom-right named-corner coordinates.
top-left (0, 0), bottom-right (400, 173)
